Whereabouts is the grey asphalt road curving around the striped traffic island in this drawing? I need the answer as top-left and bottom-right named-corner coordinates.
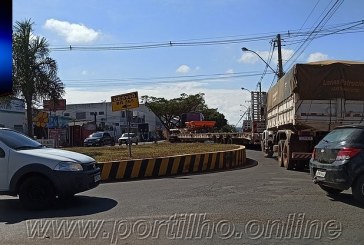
top-left (0, 150), bottom-right (364, 244)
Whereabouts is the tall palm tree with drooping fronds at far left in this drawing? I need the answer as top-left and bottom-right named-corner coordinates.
top-left (12, 20), bottom-right (64, 136)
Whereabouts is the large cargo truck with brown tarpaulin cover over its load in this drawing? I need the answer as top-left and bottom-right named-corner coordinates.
top-left (260, 60), bottom-right (364, 170)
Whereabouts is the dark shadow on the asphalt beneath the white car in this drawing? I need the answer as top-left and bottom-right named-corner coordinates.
top-left (0, 195), bottom-right (117, 224)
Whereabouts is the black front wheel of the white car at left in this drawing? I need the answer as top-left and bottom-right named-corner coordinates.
top-left (19, 176), bottom-right (56, 210)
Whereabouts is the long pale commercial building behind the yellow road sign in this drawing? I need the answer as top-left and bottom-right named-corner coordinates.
top-left (48, 102), bottom-right (162, 146)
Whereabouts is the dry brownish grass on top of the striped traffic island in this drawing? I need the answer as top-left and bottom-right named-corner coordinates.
top-left (67, 142), bottom-right (240, 162)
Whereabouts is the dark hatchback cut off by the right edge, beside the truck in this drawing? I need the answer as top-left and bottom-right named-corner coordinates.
top-left (310, 124), bottom-right (364, 203)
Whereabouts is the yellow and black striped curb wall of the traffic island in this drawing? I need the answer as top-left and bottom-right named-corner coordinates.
top-left (97, 146), bottom-right (246, 181)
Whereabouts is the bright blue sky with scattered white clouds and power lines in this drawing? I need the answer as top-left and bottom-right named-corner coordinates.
top-left (13, 0), bottom-right (364, 127)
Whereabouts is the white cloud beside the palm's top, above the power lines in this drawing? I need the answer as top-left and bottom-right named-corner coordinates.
top-left (44, 19), bottom-right (101, 44)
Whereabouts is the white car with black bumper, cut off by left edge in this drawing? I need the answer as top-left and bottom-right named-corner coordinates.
top-left (0, 128), bottom-right (101, 209)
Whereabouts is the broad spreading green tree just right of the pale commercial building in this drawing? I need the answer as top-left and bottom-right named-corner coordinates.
top-left (142, 93), bottom-right (206, 130)
